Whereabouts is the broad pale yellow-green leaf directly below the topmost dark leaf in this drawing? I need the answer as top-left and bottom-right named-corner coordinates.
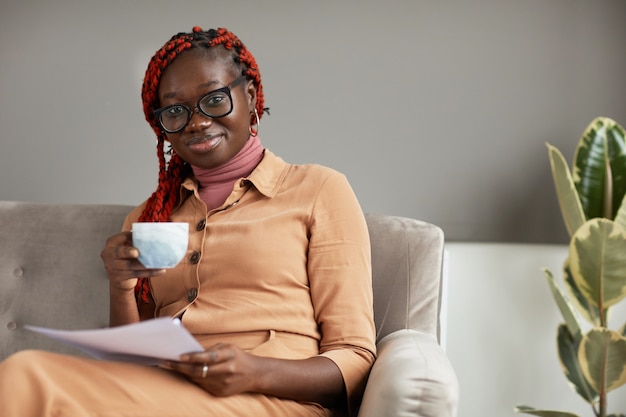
top-left (569, 218), bottom-right (626, 310)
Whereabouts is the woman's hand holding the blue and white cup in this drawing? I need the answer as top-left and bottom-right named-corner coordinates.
top-left (100, 232), bottom-right (165, 292)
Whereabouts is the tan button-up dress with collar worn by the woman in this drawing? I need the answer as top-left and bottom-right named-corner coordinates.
top-left (0, 150), bottom-right (375, 417)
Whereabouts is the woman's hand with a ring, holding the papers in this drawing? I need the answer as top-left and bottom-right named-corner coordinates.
top-left (166, 343), bottom-right (261, 397)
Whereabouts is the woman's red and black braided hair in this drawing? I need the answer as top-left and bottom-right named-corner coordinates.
top-left (135, 26), bottom-right (268, 302)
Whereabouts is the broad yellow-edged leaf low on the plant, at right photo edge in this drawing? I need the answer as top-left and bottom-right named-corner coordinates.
top-left (578, 328), bottom-right (626, 393)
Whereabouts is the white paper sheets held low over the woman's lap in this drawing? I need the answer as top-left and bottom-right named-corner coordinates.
top-left (24, 317), bottom-right (204, 365)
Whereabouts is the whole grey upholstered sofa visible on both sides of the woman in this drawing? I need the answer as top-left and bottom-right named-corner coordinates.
top-left (0, 202), bottom-right (458, 417)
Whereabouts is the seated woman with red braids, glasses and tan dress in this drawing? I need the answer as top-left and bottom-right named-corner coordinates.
top-left (0, 27), bottom-right (375, 417)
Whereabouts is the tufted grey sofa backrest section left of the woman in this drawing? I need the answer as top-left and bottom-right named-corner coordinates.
top-left (0, 202), bottom-right (132, 360)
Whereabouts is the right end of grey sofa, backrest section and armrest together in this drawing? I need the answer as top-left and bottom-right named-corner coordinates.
top-left (359, 214), bottom-right (459, 417)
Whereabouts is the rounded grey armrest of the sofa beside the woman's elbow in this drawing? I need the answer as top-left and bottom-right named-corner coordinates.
top-left (358, 329), bottom-right (459, 417)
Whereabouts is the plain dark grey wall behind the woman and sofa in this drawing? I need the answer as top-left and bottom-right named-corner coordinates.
top-left (0, 0), bottom-right (626, 242)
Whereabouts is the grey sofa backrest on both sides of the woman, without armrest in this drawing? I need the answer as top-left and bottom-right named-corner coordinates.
top-left (0, 202), bottom-right (443, 360)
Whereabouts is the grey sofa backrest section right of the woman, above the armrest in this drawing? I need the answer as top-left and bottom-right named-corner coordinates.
top-left (365, 213), bottom-right (444, 341)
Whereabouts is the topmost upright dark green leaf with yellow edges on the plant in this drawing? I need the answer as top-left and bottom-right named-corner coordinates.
top-left (572, 117), bottom-right (626, 220)
